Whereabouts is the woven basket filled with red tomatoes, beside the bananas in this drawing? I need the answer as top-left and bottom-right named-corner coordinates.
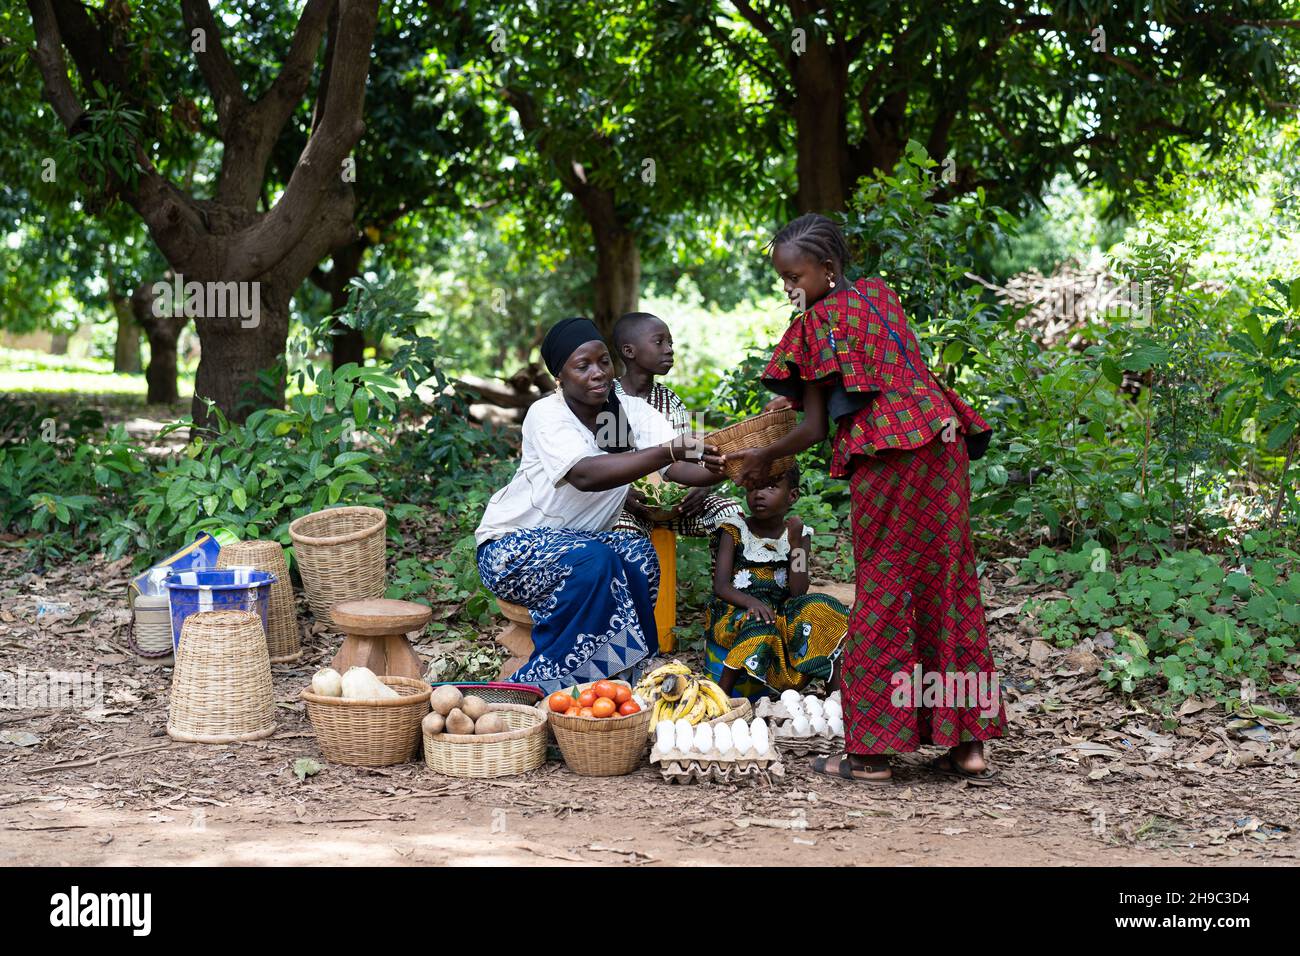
top-left (546, 680), bottom-right (651, 777)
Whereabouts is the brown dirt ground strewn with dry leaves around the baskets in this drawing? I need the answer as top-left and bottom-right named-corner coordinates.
top-left (0, 554), bottom-right (1300, 866)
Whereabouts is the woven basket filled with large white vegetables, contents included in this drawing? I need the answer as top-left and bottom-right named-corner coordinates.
top-left (302, 667), bottom-right (433, 767)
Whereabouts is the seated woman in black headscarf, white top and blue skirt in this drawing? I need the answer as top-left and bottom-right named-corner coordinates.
top-left (475, 319), bottom-right (722, 693)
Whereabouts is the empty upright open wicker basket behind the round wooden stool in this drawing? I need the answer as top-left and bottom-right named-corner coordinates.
top-left (289, 507), bottom-right (387, 623)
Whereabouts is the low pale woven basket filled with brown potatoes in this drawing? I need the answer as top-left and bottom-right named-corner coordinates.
top-left (423, 685), bottom-right (546, 777)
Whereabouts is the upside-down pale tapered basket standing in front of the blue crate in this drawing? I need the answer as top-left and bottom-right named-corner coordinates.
top-left (166, 611), bottom-right (276, 744)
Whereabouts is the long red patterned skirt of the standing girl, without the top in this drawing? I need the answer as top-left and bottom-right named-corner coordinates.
top-left (842, 438), bottom-right (1006, 754)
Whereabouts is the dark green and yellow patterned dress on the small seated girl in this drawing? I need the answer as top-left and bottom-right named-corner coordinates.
top-left (705, 518), bottom-right (849, 697)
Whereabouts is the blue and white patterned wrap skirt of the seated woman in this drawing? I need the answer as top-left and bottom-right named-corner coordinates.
top-left (478, 528), bottom-right (659, 693)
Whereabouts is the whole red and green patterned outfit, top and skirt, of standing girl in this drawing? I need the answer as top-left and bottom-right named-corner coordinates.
top-left (763, 278), bottom-right (1005, 754)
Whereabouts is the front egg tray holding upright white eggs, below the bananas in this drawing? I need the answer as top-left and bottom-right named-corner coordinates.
top-left (650, 717), bottom-right (784, 783)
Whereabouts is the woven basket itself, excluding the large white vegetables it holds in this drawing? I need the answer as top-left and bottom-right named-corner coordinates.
top-left (302, 678), bottom-right (433, 767)
